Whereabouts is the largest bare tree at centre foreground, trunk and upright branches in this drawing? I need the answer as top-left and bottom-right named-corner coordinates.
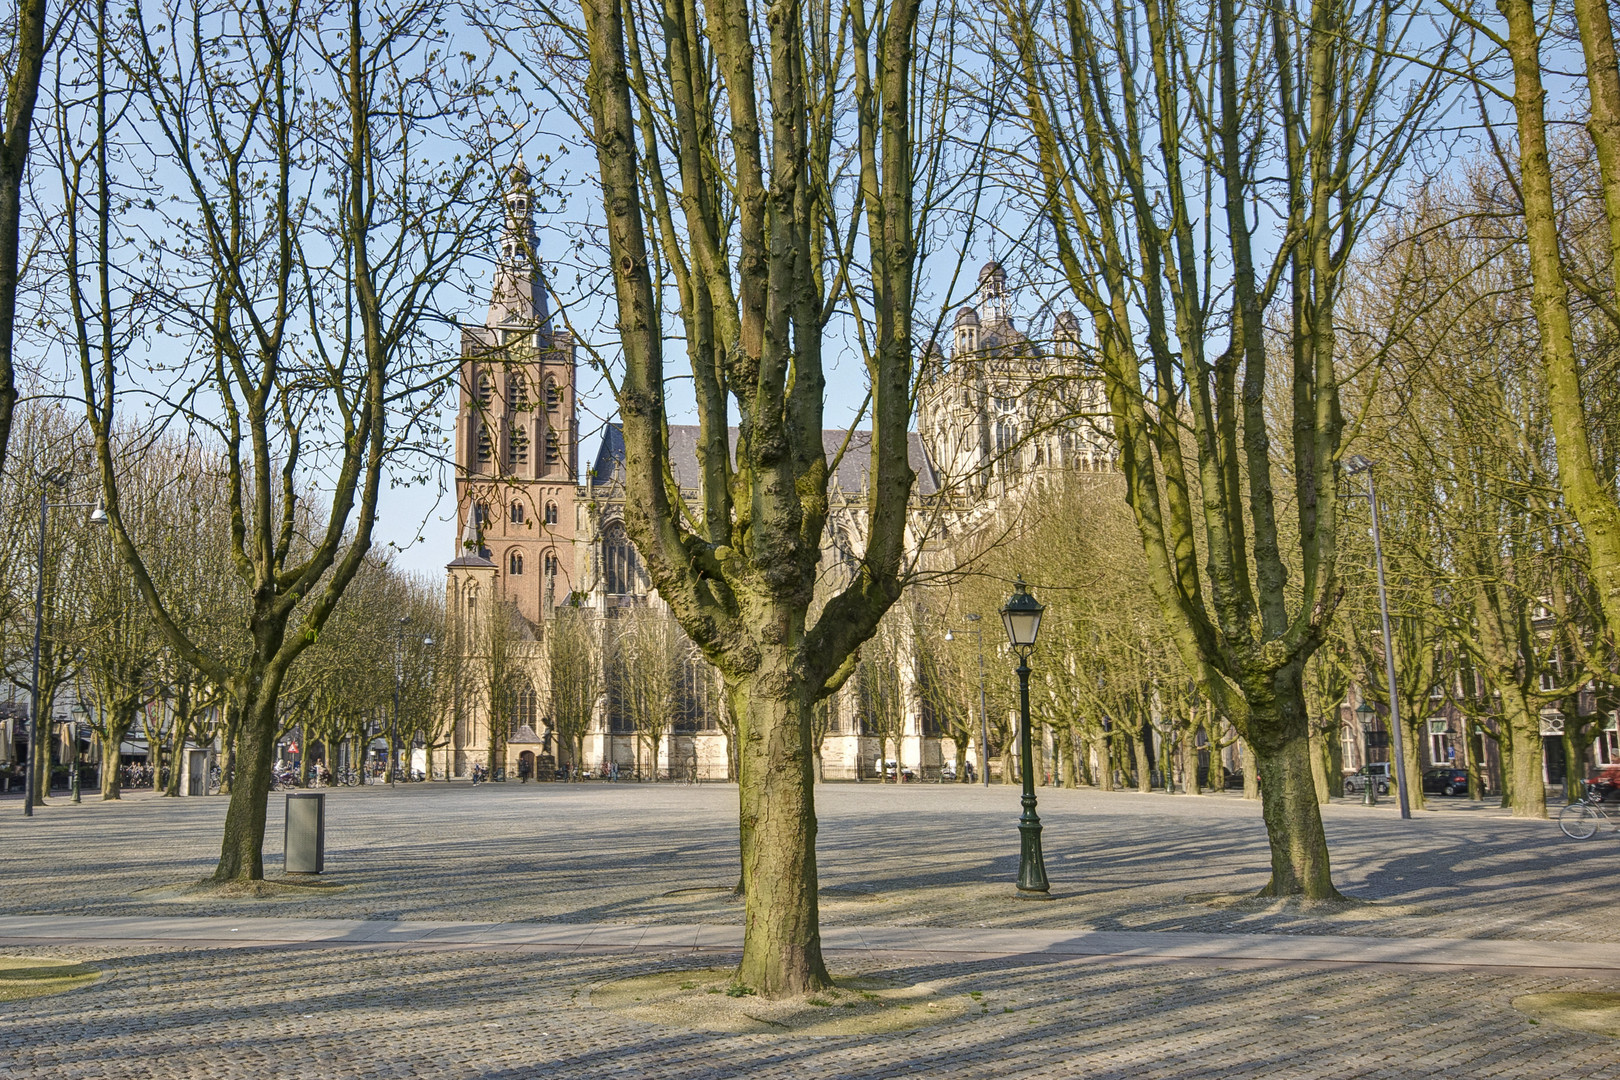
top-left (552, 0), bottom-right (954, 997)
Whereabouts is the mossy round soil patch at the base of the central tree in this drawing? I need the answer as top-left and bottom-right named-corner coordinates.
top-left (590, 968), bottom-right (978, 1036)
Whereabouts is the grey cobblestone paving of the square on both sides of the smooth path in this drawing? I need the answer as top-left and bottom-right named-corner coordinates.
top-left (0, 784), bottom-right (1620, 1078)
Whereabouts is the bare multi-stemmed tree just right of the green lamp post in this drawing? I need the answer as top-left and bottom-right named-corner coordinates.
top-left (998, 0), bottom-right (1448, 897)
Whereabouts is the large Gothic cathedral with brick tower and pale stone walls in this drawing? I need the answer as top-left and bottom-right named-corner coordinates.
top-left (429, 162), bottom-right (1113, 779)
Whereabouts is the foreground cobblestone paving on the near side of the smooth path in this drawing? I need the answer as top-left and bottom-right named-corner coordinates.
top-left (0, 947), bottom-right (1620, 1080)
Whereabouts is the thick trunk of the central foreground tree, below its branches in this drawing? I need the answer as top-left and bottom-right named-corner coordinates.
top-left (729, 660), bottom-right (833, 997)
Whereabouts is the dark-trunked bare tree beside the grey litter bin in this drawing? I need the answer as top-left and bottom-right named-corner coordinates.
top-left (68, 0), bottom-right (494, 881)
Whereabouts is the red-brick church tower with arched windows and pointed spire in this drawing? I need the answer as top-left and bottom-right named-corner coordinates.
top-left (449, 157), bottom-right (580, 625)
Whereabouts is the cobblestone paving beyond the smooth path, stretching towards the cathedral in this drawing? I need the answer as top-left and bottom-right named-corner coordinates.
top-left (0, 784), bottom-right (1620, 941)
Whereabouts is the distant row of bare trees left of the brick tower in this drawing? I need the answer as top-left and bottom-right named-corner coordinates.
top-left (0, 403), bottom-right (471, 800)
